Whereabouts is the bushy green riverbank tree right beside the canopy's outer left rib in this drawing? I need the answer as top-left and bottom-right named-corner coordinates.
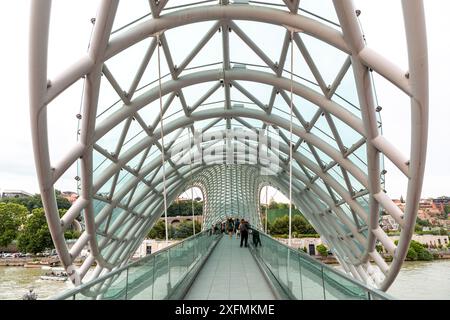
top-left (17, 208), bottom-right (53, 253)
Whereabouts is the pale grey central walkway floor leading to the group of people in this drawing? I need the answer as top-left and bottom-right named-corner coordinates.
top-left (185, 235), bottom-right (275, 300)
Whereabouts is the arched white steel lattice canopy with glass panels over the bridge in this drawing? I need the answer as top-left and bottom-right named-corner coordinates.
top-left (30, 0), bottom-right (428, 290)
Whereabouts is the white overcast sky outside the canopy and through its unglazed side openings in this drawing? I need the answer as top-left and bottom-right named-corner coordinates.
top-left (0, 0), bottom-right (450, 202)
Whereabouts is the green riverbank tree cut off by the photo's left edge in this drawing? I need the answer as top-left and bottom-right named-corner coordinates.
top-left (0, 203), bottom-right (27, 247)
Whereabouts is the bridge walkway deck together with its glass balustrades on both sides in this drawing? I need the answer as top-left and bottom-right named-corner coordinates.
top-left (53, 230), bottom-right (391, 300)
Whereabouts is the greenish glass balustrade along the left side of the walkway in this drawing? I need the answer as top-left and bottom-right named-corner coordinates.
top-left (53, 230), bottom-right (220, 300)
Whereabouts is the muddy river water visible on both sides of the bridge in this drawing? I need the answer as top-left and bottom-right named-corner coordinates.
top-left (0, 260), bottom-right (450, 300)
